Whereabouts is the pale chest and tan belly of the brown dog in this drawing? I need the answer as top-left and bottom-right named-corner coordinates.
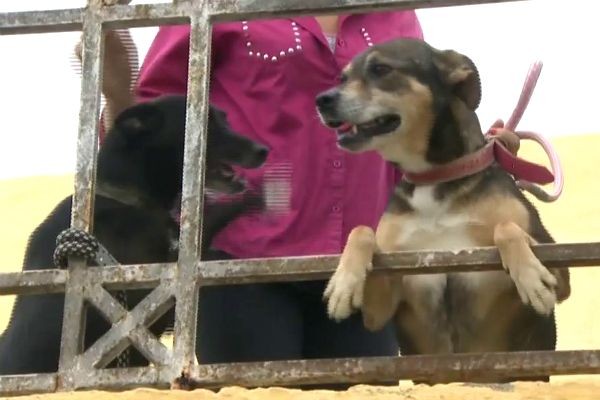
top-left (377, 187), bottom-right (510, 352)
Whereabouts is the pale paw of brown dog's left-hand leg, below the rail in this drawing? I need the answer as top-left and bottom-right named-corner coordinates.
top-left (323, 264), bottom-right (369, 321)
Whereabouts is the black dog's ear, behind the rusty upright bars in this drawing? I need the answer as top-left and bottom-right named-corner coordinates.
top-left (114, 103), bottom-right (164, 137)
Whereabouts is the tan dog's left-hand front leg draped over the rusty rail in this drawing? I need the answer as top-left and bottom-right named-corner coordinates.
top-left (323, 226), bottom-right (376, 321)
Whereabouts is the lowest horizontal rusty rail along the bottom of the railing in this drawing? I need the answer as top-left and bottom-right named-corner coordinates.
top-left (0, 350), bottom-right (600, 395)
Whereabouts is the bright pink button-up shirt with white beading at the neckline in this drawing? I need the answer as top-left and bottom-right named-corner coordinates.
top-left (137, 11), bottom-right (422, 258)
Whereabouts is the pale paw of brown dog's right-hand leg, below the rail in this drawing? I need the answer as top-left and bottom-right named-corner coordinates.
top-left (510, 258), bottom-right (557, 315)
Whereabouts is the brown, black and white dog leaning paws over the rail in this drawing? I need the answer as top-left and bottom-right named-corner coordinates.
top-left (317, 39), bottom-right (570, 380)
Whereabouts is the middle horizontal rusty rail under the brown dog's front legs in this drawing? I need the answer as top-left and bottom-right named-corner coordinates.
top-left (198, 243), bottom-right (600, 285)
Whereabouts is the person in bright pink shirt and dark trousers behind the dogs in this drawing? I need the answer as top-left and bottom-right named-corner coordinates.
top-left (91, 11), bottom-right (516, 378)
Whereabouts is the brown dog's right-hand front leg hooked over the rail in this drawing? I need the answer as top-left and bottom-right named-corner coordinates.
top-left (494, 222), bottom-right (557, 315)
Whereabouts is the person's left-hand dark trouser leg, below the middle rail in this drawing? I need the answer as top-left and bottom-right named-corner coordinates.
top-left (196, 283), bottom-right (304, 364)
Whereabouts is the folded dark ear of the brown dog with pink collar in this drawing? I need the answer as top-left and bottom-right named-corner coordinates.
top-left (433, 50), bottom-right (481, 111)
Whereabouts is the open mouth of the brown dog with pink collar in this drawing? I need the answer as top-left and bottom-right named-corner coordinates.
top-left (328, 114), bottom-right (402, 145)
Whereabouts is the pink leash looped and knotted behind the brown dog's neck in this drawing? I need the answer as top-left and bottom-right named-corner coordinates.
top-left (496, 61), bottom-right (564, 202)
